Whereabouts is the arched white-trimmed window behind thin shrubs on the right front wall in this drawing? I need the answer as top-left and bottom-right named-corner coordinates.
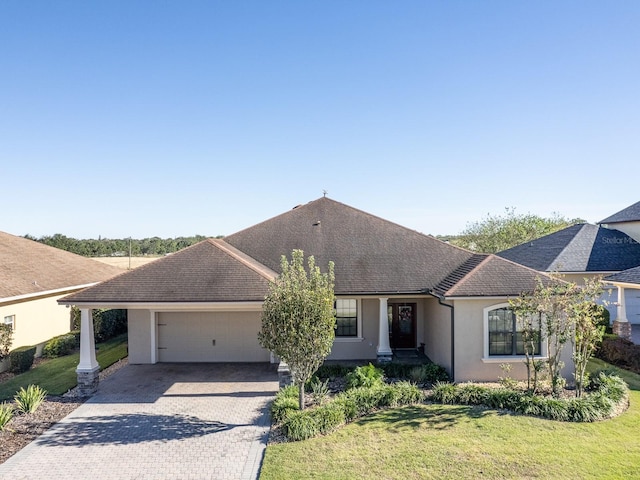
top-left (486, 307), bottom-right (541, 357)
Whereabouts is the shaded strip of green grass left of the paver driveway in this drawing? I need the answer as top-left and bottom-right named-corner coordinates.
top-left (0, 333), bottom-right (127, 402)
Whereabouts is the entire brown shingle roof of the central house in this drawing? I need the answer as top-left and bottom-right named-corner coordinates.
top-left (63, 197), bottom-right (556, 304)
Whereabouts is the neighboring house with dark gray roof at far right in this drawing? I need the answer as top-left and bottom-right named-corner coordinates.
top-left (497, 202), bottom-right (640, 340)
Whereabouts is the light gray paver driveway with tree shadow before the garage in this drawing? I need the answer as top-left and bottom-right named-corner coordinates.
top-left (0, 364), bottom-right (278, 480)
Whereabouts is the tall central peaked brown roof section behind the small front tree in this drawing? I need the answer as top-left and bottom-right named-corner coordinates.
top-left (225, 197), bottom-right (473, 294)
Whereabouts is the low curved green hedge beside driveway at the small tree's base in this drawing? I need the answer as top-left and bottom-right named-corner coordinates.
top-left (271, 381), bottom-right (424, 441)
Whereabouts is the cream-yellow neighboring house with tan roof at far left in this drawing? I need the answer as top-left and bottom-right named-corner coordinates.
top-left (0, 232), bottom-right (122, 360)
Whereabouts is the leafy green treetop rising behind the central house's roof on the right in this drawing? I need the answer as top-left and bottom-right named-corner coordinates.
top-left (451, 207), bottom-right (585, 253)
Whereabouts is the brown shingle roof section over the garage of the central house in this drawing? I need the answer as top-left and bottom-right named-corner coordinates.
top-left (62, 239), bottom-right (275, 303)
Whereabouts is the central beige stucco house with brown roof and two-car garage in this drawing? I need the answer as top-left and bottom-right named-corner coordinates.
top-left (60, 197), bottom-right (560, 390)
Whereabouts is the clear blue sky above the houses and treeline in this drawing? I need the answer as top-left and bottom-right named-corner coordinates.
top-left (0, 0), bottom-right (640, 238)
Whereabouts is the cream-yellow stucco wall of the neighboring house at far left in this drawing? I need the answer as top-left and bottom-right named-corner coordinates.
top-left (0, 292), bottom-right (71, 349)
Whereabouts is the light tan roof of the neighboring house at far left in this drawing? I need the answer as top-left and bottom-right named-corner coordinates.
top-left (0, 232), bottom-right (123, 299)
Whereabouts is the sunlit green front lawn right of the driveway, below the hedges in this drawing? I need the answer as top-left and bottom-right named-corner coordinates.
top-left (260, 360), bottom-right (640, 480)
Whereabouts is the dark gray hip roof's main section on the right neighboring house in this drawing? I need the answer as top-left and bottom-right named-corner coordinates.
top-left (497, 223), bottom-right (640, 272)
